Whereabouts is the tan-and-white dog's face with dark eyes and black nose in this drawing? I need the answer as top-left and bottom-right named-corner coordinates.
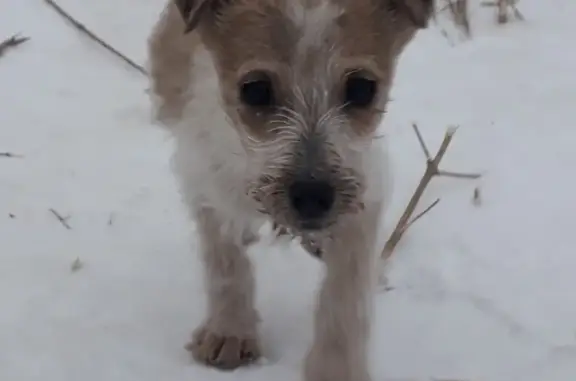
top-left (175, 0), bottom-right (433, 232)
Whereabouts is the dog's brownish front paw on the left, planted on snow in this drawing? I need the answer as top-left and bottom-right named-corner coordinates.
top-left (186, 327), bottom-right (261, 370)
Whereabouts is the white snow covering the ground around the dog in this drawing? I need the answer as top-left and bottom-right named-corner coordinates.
top-left (0, 0), bottom-right (576, 381)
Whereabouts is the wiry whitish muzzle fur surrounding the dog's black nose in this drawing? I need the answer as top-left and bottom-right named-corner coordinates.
top-left (246, 102), bottom-right (364, 236)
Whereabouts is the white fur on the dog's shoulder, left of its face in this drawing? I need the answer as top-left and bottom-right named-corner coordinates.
top-left (166, 47), bottom-right (264, 237)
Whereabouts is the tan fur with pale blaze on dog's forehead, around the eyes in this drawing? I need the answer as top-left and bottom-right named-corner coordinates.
top-left (189, 0), bottom-right (424, 138)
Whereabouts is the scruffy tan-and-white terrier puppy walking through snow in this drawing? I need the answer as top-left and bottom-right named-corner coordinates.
top-left (149, 0), bottom-right (433, 381)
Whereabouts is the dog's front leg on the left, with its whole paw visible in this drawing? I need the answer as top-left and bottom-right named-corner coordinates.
top-left (187, 208), bottom-right (260, 369)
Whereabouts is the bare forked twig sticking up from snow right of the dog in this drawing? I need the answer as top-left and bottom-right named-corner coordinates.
top-left (382, 124), bottom-right (480, 259)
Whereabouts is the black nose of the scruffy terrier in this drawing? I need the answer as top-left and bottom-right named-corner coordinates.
top-left (288, 180), bottom-right (335, 220)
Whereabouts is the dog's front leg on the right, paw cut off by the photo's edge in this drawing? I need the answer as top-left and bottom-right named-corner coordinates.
top-left (304, 205), bottom-right (380, 381)
